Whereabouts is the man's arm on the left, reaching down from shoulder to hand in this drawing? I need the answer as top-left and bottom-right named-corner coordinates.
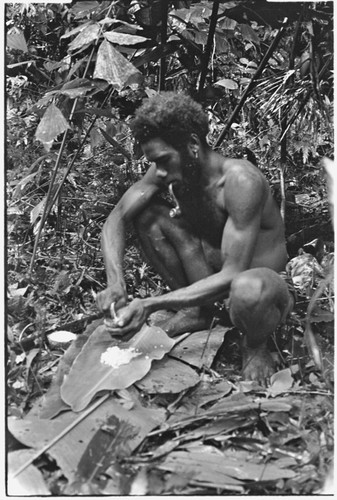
top-left (97, 167), bottom-right (160, 313)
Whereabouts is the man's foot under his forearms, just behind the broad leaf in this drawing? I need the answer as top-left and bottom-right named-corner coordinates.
top-left (156, 307), bottom-right (212, 337)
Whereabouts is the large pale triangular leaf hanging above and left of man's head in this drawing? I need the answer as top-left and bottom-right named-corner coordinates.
top-left (94, 40), bottom-right (143, 91)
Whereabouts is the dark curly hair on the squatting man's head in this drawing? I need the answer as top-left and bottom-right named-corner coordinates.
top-left (131, 92), bottom-right (208, 149)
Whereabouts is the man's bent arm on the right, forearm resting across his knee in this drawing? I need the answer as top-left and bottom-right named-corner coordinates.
top-left (117, 168), bottom-right (267, 333)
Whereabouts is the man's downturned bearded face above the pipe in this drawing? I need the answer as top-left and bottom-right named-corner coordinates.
top-left (142, 137), bottom-right (193, 186)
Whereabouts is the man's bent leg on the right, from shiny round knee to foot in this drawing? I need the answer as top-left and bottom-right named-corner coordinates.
top-left (229, 268), bottom-right (293, 382)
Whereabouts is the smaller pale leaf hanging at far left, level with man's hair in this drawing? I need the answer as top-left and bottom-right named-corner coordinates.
top-left (35, 103), bottom-right (70, 149)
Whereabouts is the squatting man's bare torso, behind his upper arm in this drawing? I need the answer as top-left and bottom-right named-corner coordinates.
top-left (165, 153), bottom-right (287, 271)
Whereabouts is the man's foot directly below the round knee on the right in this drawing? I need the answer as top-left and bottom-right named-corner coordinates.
top-left (242, 345), bottom-right (276, 385)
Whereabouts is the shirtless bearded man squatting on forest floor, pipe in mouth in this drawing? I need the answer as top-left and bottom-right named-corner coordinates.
top-left (97, 92), bottom-right (293, 381)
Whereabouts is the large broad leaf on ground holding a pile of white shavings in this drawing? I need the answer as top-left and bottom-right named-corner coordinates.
top-left (61, 325), bottom-right (174, 411)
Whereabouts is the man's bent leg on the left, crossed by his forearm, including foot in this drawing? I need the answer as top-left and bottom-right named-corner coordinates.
top-left (134, 203), bottom-right (214, 336)
